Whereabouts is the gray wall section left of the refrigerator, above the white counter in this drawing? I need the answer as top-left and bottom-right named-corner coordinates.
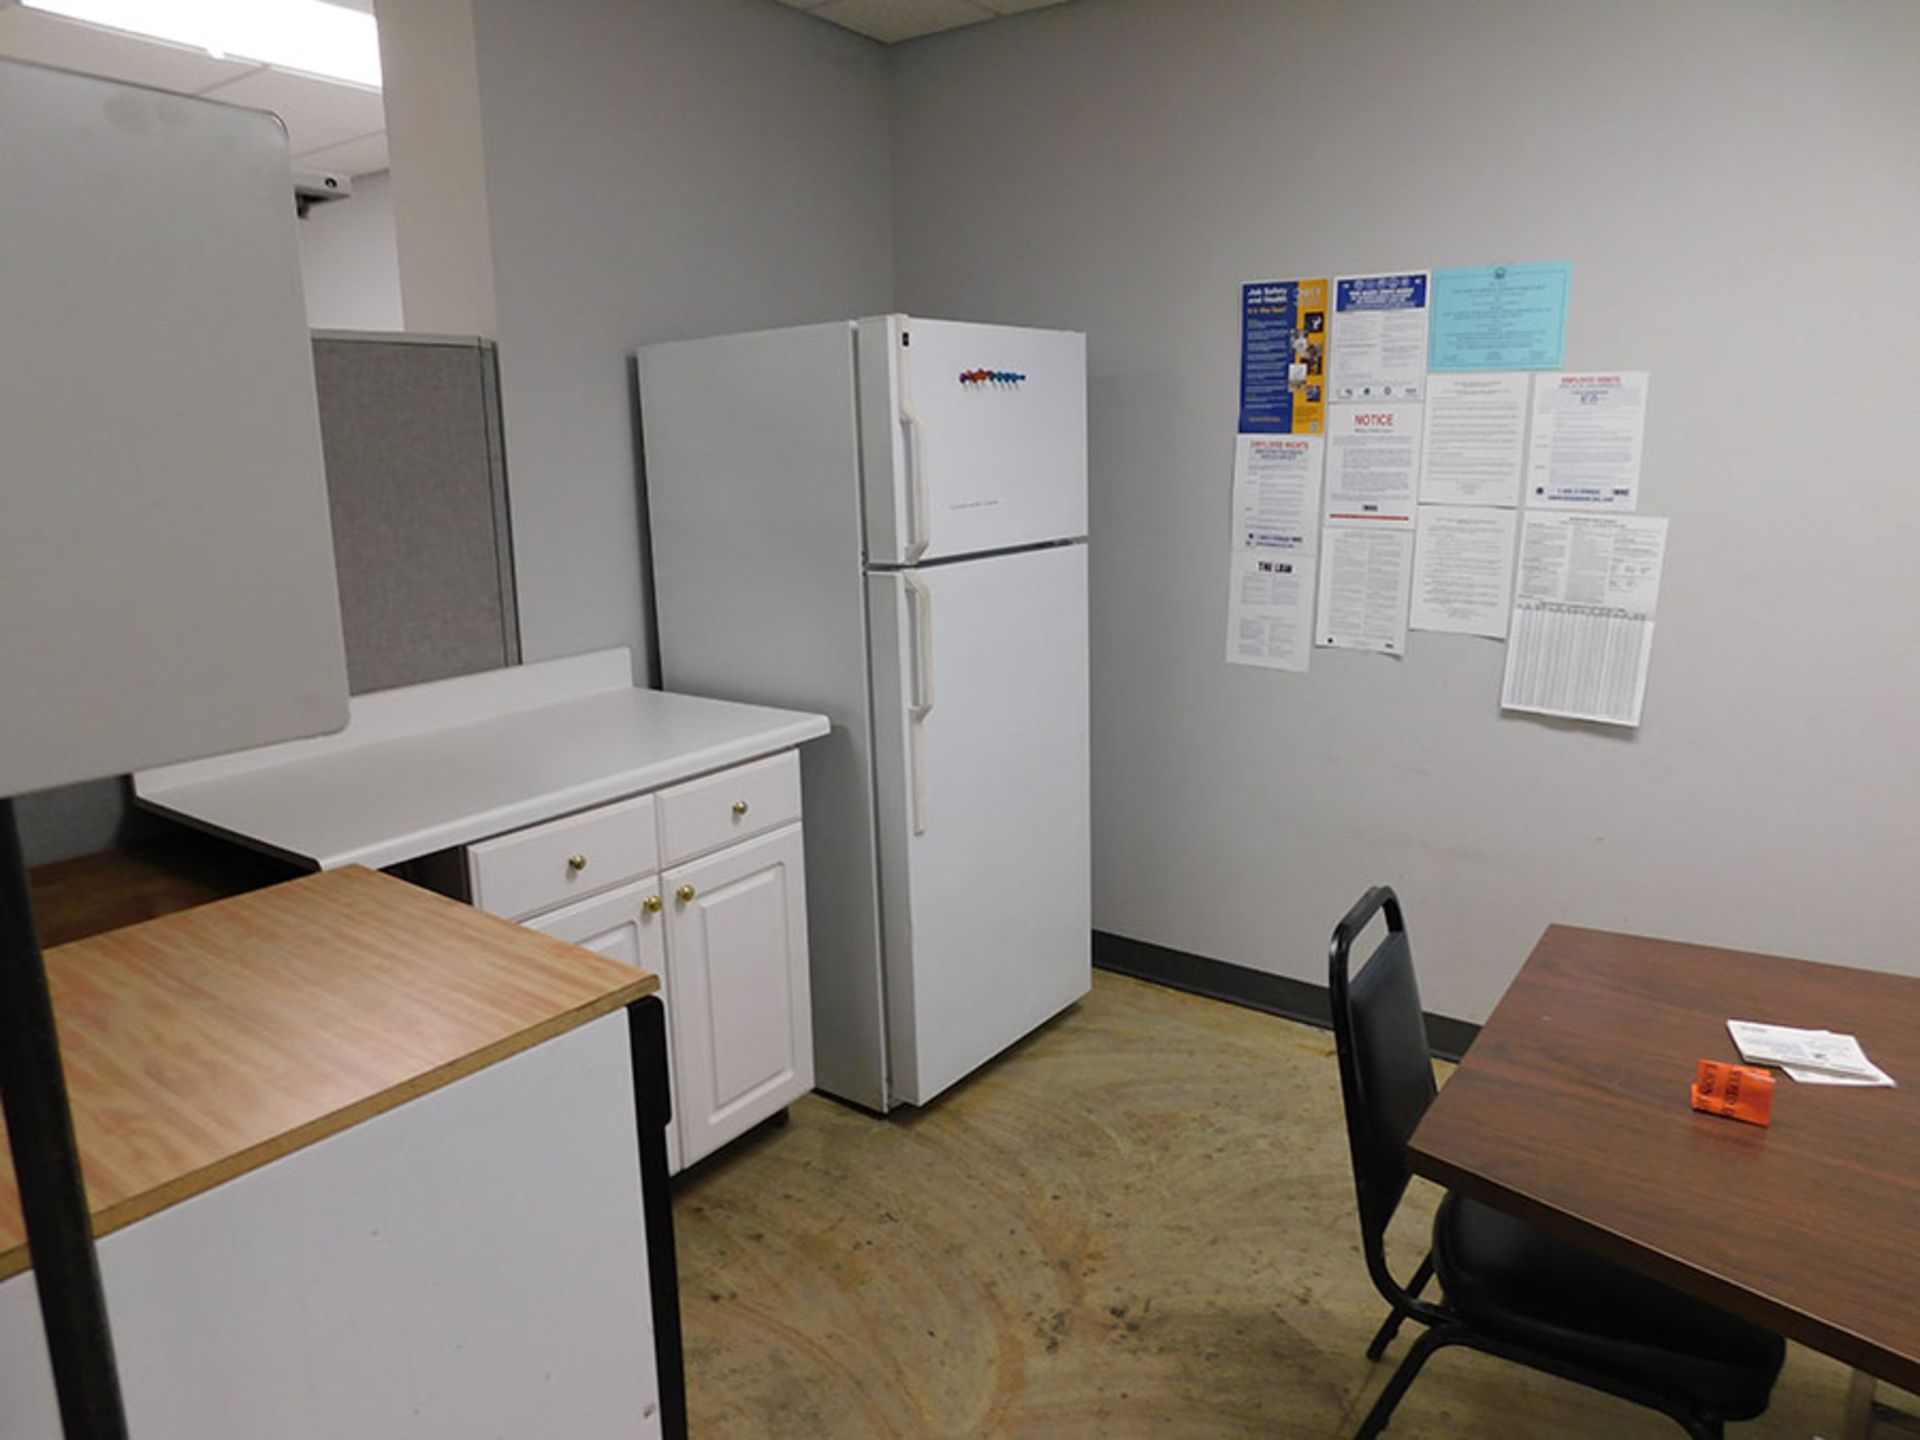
top-left (474, 0), bottom-right (893, 678)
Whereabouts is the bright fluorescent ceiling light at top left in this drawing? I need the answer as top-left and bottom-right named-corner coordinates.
top-left (21, 0), bottom-right (380, 90)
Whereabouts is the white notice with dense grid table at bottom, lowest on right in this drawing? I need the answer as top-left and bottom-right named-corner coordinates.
top-left (1500, 513), bottom-right (1667, 726)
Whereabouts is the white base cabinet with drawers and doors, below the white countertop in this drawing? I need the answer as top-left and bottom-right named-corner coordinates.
top-left (467, 751), bottom-right (814, 1169)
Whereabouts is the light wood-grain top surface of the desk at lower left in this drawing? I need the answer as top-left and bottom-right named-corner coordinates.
top-left (0, 868), bottom-right (660, 1279)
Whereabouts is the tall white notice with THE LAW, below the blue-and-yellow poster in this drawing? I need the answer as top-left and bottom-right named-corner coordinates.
top-left (1227, 436), bottom-right (1327, 670)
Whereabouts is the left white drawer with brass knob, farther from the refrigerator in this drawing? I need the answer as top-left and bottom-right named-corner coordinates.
top-left (467, 795), bottom-right (659, 920)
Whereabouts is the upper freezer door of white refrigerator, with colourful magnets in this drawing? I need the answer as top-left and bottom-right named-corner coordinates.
top-left (860, 315), bottom-right (1087, 564)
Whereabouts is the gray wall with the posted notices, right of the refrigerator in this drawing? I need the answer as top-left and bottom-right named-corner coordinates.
top-left (893, 0), bottom-right (1920, 1020)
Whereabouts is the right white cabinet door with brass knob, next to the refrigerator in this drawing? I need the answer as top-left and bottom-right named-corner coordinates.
top-left (664, 826), bottom-right (814, 1164)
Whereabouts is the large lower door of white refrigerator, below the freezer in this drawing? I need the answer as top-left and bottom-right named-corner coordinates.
top-left (868, 545), bottom-right (1092, 1104)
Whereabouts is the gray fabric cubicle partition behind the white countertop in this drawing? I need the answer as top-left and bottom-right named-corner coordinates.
top-left (19, 330), bottom-right (520, 864)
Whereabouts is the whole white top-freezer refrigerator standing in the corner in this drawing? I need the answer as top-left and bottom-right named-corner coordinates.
top-left (639, 315), bottom-right (1091, 1110)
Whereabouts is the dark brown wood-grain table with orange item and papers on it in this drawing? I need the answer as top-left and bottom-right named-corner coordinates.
top-left (1411, 925), bottom-right (1920, 1390)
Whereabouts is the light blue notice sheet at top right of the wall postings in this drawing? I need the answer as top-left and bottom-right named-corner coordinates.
top-left (1427, 259), bottom-right (1572, 371)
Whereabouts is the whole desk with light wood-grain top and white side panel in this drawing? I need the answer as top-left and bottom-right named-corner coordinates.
top-left (0, 866), bottom-right (684, 1440)
